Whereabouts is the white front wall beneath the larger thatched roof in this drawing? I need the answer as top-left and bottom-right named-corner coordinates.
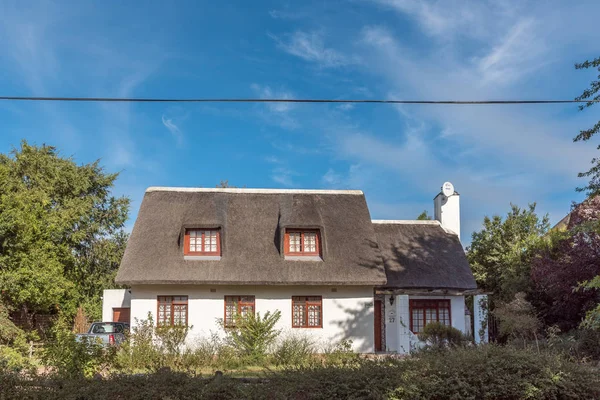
top-left (131, 285), bottom-right (374, 353)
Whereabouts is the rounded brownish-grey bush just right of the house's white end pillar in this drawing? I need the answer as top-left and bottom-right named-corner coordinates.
top-left (494, 293), bottom-right (542, 341)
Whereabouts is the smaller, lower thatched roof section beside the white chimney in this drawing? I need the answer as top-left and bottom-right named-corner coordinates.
top-left (373, 221), bottom-right (477, 289)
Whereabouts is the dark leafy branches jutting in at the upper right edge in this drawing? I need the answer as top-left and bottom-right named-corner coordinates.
top-left (573, 57), bottom-right (600, 195)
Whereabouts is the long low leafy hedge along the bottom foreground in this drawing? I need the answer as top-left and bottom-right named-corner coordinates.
top-left (0, 345), bottom-right (600, 400)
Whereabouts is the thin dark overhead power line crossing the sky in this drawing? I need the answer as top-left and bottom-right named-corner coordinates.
top-left (0, 96), bottom-right (600, 105)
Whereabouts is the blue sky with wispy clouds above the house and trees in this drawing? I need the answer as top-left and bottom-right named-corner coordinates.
top-left (0, 0), bottom-right (600, 243)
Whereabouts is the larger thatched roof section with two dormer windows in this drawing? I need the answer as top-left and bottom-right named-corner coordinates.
top-left (116, 188), bottom-right (386, 286)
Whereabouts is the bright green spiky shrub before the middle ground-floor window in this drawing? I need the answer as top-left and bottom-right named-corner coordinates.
top-left (220, 310), bottom-right (281, 362)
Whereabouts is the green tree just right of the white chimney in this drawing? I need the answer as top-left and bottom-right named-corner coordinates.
top-left (467, 203), bottom-right (549, 301)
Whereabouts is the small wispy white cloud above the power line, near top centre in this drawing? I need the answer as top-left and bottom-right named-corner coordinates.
top-left (269, 31), bottom-right (356, 68)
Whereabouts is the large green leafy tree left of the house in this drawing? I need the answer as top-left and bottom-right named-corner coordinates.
top-left (0, 141), bottom-right (129, 322)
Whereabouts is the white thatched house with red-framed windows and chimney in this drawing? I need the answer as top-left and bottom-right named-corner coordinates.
top-left (103, 187), bottom-right (484, 352)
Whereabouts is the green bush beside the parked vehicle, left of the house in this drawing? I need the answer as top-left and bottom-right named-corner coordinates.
top-left (42, 317), bottom-right (114, 378)
